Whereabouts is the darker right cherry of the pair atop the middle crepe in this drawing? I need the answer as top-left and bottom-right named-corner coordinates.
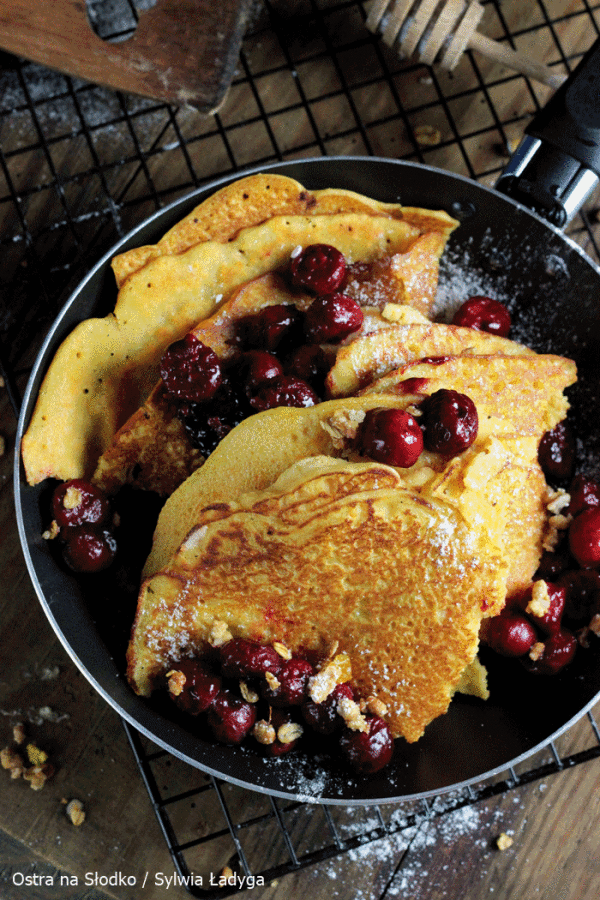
top-left (421, 388), bottom-right (479, 456)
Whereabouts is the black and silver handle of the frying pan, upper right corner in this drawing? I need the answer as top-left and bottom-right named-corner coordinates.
top-left (496, 39), bottom-right (600, 228)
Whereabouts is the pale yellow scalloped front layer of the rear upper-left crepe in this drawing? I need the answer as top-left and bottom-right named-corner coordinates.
top-left (22, 213), bottom-right (440, 484)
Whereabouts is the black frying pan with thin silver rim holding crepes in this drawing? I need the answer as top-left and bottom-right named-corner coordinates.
top-left (15, 40), bottom-right (600, 804)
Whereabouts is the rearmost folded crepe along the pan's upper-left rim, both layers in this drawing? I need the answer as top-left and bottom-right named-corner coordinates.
top-left (22, 176), bottom-right (457, 484)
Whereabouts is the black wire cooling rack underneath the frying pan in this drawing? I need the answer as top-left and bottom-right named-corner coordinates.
top-left (0, 0), bottom-right (600, 897)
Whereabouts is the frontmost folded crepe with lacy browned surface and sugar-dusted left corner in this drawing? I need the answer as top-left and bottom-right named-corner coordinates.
top-left (128, 459), bottom-right (507, 741)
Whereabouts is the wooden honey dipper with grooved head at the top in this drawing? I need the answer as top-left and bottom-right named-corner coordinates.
top-left (366, 0), bottom-right (567, 89)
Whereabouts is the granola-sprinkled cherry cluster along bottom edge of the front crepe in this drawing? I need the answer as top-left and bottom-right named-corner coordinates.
top-left (168, 638), bottom-right (394, 774)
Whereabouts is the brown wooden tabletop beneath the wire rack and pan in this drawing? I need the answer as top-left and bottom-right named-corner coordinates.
top-left (0, 0), bottom-right (600, 900)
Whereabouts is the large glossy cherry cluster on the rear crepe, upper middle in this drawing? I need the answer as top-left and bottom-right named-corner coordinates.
top-left (160, 244), bottom-right (363, 456)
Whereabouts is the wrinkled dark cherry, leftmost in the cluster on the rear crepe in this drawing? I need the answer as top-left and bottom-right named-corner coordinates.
top-left (160, 332), bottom-right (223, 403)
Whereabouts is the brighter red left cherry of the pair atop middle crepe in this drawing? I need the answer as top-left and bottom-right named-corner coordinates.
top-left (359, 409), bottom-right (423, 469)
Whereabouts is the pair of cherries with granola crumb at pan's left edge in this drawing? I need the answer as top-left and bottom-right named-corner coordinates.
top-left (52, 479), bottom-right (117, 573)
